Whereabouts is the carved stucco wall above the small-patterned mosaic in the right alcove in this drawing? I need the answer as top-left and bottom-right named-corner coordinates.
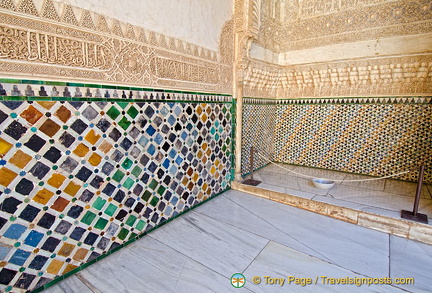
top-left (244, 0), bottom-right (432, 98)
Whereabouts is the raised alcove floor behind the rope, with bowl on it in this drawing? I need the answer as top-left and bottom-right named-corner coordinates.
top-left (250, 164), bottom-right (432, 225)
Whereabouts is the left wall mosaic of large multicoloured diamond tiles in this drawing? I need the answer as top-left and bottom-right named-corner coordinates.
top-left (0, 81), bottom-right (232, 292)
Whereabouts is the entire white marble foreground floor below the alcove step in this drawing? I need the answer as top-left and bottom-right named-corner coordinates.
top-left (44, 190), bottom-right (432, 293)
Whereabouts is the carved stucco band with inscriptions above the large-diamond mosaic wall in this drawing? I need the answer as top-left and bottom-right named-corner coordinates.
top-left (0, 0), bottom-right (233, 93)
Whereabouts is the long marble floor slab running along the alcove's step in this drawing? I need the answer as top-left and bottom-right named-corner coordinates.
top-left (226, 191), bottom-right (389, 276)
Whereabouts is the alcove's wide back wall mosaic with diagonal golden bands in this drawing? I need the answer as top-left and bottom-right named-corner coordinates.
top-left (274, 97), bottom-right (432, 183)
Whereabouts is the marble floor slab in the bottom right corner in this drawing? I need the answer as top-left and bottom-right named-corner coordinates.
top-left (390, 236), bottom-right (432, 292)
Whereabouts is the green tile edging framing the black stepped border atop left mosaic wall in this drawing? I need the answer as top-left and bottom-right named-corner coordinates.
top-left (0, 78), bottom-right (232, 103)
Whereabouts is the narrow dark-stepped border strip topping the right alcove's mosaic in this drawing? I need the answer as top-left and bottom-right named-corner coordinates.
top-left (243, 96), bottom-right (432, 105)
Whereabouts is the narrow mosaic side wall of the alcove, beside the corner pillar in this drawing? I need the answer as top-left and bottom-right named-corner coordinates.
top-left (241, 98), bottom-right (277, 175)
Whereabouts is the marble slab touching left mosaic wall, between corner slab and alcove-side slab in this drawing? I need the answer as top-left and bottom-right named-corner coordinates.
top-left (151, 208), bottom-right (268, 277)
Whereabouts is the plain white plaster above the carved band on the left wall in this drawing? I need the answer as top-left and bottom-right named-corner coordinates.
top-left (55, 0), bottom-right (233, 51)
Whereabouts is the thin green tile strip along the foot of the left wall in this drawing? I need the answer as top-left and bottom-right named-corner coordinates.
top-left (29, 186), bottom-right (231, 293)
